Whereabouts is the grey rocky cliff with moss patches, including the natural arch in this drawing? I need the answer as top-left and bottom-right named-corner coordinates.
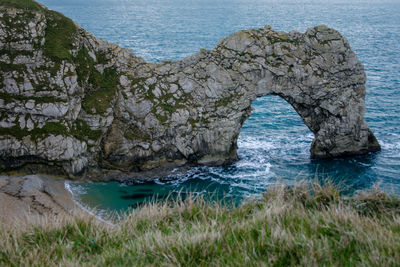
top-left (0, 0), bottom-right (380, 180)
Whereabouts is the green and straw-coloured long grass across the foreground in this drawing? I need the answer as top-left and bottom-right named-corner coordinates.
top-left (0, 184), bottom-right (400, 266)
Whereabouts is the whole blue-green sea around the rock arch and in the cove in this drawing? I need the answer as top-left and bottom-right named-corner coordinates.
top-left (39, 0), bottom-right (400, 215)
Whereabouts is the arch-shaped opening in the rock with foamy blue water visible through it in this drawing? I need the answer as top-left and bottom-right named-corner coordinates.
top-left (235, 95), bottom-right (314, 181)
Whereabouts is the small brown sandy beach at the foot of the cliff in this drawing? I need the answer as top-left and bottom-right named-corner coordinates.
top-left (0, 175), bottom-right (79, 224)
